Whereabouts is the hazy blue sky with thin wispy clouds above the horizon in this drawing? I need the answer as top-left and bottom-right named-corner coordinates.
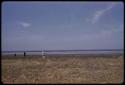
top-left (1, 1), bottom-right (124, 50)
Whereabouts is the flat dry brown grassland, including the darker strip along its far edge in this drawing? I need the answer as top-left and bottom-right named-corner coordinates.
top-left (1, 55), bottom-right (124, 84)
